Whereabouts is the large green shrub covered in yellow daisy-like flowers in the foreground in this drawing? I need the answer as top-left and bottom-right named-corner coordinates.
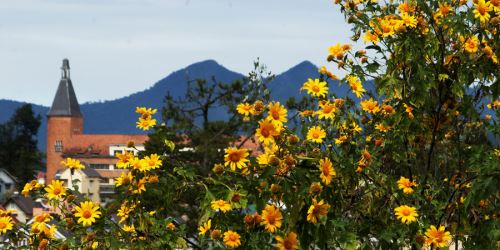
top-left (0, 0), bottom-right (500, 250)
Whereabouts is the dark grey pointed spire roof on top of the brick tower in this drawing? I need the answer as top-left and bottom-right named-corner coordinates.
top-left (47, 59), bottom-right (82, 116)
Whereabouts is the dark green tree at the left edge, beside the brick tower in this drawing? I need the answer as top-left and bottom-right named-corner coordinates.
top-left (0, 104), bottom-right (42, 186)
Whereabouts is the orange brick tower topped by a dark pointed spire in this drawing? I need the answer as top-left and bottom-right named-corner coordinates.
top-left (46, 59), bottom-right (83, 183)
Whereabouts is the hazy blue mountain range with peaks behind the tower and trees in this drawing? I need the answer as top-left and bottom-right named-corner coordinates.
top-left (0, 60), bottom-right (332, 151)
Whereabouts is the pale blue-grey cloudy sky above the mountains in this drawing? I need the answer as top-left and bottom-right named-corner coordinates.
top-left (0, 0), bottom-right (350, 106)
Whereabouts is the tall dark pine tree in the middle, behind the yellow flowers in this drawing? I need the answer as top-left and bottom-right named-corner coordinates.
top-left (131, 62), bottom-right (272, 244)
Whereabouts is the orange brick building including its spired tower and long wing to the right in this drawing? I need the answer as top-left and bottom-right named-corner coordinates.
top-left (46, 59), bottom-right (148, 203)
